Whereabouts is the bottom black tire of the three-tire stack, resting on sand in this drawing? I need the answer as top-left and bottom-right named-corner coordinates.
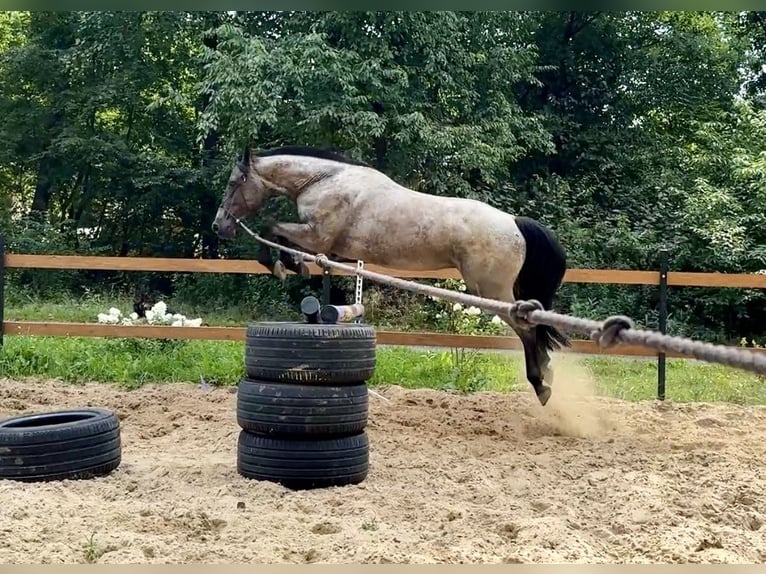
top-left (237, 430), bottom-right (370, 490)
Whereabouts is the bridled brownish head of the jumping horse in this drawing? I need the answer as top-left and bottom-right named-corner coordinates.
top-left (211, 146), bottom-right (271, 239)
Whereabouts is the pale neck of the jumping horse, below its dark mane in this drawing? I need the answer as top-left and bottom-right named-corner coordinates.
top-left (258, 156), bottom-right (344, 200)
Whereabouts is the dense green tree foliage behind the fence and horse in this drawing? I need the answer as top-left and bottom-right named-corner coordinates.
top-left (0, 11), bottom-right (766, 344)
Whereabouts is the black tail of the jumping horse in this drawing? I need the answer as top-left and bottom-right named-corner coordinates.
top-left (513, 216), bottom-right (571, 351)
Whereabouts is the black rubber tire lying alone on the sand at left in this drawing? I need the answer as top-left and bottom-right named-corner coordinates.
top-left (0, 407), bottom-right (122, 482)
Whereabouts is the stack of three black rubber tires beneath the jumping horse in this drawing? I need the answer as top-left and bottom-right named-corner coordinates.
top-left (237, 322), bottom-right (376, 489)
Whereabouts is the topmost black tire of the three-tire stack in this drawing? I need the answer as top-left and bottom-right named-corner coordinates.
top-left (245, 322), bottom-right (376, 385)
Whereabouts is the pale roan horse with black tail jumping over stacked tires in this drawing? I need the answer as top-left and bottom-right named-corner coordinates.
top-left (212, 146), bottom-right (571, 406)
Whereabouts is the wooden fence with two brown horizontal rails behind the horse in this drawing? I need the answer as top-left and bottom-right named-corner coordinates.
top-left (0, 248), bottom-right (766, 399)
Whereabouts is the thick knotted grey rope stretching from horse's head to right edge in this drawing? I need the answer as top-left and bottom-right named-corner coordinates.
top-left (236, 219), bottom-right (766, 375)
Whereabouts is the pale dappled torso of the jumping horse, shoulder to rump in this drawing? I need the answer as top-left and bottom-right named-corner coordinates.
top-left (310, 166), bottom-right (523, 270)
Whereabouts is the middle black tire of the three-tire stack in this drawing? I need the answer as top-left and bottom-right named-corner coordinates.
top-left (237, 378), bottom-right (368, 437)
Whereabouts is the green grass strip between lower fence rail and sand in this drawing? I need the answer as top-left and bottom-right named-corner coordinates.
top-left (0, 336), bottom-right (766, 404)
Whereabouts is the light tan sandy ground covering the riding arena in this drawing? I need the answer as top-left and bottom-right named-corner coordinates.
top-left (0, 358), bottom-right (766, 563)
